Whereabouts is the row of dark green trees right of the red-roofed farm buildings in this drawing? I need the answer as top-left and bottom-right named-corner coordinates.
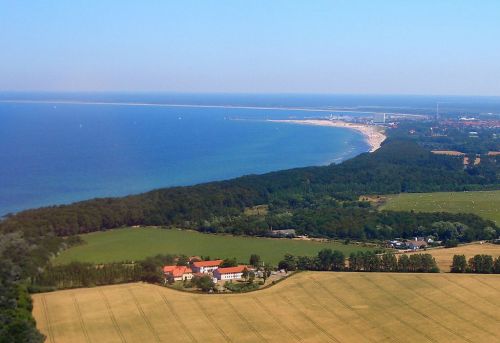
top-left (278, 249), bottom-right (439, 273)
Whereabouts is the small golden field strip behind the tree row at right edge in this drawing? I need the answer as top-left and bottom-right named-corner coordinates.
top-left (409, 243), bottom-right (500, 272)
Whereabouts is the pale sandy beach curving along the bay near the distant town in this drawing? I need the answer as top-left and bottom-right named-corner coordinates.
top-left (267, 119), bottom-right (386, 152)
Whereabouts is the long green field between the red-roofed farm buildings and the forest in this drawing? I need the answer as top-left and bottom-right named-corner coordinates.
top-left (55, 227), bottom-right (376, 264)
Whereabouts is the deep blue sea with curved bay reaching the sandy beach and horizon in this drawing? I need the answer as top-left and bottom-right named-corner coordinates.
top-left (0, 93), bottom-right (500, 215)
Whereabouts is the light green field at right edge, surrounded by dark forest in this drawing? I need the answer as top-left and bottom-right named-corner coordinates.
top-left (380, 191), bottom-right (500, 225)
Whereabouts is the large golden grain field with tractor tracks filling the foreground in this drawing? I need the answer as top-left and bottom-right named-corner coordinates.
top-left (33, 272), bottom-right (500, 343)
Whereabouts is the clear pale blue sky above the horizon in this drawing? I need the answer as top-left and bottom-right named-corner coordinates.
top-left (0, 0), bottom-right (500, 96)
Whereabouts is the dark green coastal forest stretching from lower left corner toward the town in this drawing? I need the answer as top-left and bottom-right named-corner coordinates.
top-left (0, 138), bottom-right (500, 342)
